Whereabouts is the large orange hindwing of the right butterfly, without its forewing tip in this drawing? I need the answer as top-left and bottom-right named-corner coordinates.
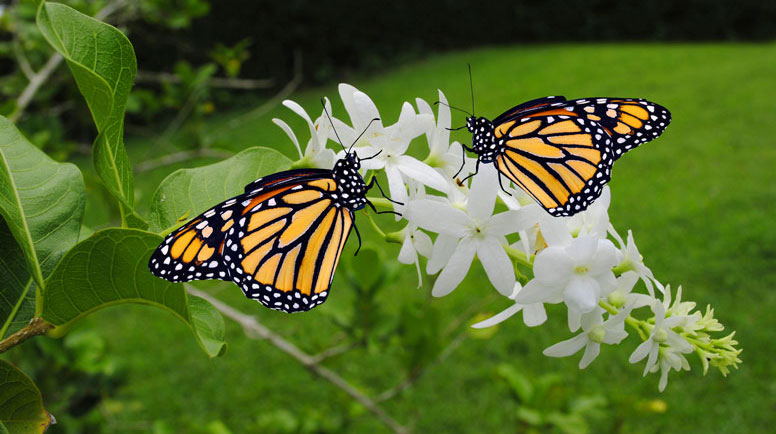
top-left (494, 109), bottom-right (614, 216)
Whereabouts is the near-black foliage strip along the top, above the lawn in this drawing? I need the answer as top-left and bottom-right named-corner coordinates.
top-left (132, 0), bottom-right (776, 83)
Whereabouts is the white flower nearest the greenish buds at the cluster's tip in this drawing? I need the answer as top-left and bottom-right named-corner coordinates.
top-left (628, 299), bottom-right (694, 380)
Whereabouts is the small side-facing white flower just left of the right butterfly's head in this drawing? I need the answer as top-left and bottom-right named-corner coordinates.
top-left (415, 90), bottom-right (477, 178)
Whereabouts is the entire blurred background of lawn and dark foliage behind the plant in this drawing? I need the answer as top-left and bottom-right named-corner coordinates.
top-left (0, 0), bottom-right (776, 433)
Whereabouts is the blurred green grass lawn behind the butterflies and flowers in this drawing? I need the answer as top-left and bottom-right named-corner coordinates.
top-left (76, 44), bottom-right (776, 433)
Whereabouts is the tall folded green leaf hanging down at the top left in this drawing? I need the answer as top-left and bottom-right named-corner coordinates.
top-left (37, 2), bottom-right (145, 227)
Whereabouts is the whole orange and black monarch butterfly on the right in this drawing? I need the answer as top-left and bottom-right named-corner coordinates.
top-left (464, 96), bottom-right (671, 216)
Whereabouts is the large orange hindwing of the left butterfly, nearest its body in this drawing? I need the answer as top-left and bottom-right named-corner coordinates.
top-left (223, 175), bottom-right (353, 312)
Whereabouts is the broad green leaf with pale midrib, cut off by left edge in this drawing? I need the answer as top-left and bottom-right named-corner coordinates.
top-left (0, 116), bottom-right (86, 328)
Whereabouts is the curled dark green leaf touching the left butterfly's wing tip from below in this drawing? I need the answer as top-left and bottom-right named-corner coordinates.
top-left (42, 228), bottom-right (226, 357)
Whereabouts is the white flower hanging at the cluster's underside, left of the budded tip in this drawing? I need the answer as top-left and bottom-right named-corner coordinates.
top-left (544, 307), bottom-right (628, 369)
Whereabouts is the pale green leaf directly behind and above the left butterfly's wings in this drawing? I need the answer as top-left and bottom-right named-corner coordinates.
top-left (149, 147), bottom-right (291, 231)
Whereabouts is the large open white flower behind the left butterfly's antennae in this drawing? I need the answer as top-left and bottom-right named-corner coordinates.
top-left (335, 83), bottom-right (448, 211)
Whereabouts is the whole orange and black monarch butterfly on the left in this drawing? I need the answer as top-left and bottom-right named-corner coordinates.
top-left (148, 113), bottom-right (390, 313)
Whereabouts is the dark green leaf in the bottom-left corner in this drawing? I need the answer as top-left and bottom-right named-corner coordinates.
top-left (0, 359), bottom-right (51, 434)
